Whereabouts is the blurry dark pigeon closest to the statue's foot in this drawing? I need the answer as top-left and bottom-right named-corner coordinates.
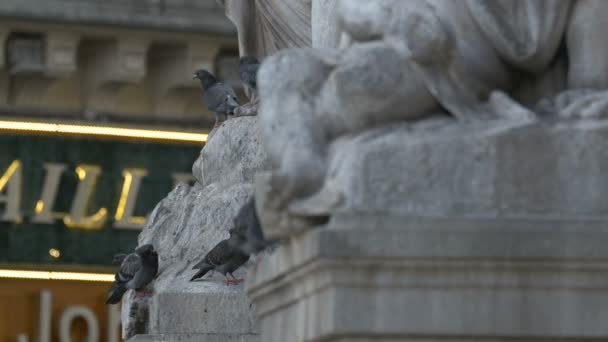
top-left (230, 196), bottom-right (275, 255)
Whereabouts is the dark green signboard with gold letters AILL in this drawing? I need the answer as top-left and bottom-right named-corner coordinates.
top-left (0, 134), bottom-right (201, 266)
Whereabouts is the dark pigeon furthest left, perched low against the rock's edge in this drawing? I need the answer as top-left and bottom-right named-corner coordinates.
top-left (106, 244), bottom-right (158, 304)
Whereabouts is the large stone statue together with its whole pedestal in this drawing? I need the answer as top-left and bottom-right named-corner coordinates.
top-left (221, 0), bottom-right (608, 342)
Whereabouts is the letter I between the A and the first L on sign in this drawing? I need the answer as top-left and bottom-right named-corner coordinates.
top-left (32, 163), bottom-right (66, 223)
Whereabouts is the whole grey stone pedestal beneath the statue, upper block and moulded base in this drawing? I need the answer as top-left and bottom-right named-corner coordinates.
top-left (247, 119), bottom-right (608, 342)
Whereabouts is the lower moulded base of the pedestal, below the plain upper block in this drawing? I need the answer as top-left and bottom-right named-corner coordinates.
top-left (247, 215), bottom-right (608, 342)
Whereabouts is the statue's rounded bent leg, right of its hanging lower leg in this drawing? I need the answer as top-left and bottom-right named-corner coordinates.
top-left (317, 41), bottom-right (439, 136)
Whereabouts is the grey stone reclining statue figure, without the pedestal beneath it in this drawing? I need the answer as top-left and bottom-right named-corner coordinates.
top-left (233, 0), bottom-right (608, 237)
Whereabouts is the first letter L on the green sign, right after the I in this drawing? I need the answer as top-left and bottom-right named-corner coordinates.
top-left (63, 165), bottom-right (108, 229)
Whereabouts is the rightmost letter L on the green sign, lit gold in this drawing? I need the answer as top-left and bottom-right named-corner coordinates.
top-left (114, 169), bottom-right (148, 229)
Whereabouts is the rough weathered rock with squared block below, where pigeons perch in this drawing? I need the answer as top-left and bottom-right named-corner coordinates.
top-left (123, 117), bottom-right (265, 341)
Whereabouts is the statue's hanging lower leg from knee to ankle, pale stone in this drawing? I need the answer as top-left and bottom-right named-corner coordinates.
top-left (258, 49), bottom-right (333, 209)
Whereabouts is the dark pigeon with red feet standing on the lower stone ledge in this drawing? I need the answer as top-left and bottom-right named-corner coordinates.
top-left (190, 228), bottom-right (249, 285)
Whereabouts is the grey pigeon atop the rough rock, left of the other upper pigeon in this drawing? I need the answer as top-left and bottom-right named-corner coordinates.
top-left (192, 69), bottom-right (239, 128)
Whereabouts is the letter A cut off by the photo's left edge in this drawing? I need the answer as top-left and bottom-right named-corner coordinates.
top-left (0, 160), bottom-right (22, 223)
